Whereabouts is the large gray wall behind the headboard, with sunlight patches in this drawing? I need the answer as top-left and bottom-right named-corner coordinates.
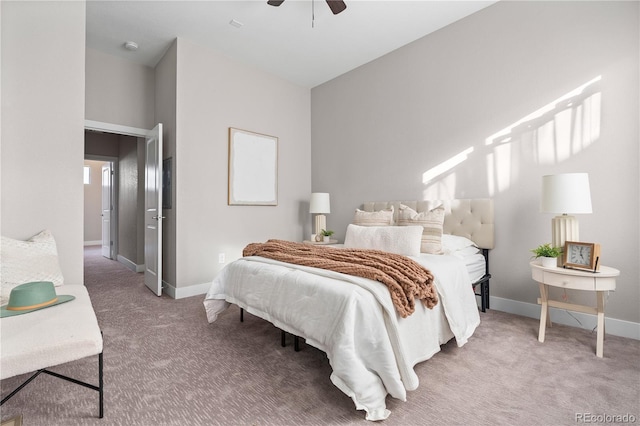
top-left (311, 2), bottom-right (640, 325)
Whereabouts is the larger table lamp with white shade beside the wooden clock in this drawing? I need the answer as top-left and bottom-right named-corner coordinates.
top-left (540, 173), bottom-right (592, 248)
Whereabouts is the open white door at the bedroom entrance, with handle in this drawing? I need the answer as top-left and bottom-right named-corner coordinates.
top-left (144, 123), bottom-right (164, 296)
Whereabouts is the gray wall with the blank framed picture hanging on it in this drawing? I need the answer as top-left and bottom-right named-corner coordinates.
top-left (167, 38), bottom-right (311, 288)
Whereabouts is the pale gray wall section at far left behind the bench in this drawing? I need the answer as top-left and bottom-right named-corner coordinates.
top-left (0, 1), bottom-right (85, 284)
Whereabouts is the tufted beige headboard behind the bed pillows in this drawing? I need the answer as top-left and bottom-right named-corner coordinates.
top-left (363, 198), bottom-right (495, 249)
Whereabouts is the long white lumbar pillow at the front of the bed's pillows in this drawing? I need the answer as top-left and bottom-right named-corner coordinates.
top-left (344, 224), bottom-right (422, 256)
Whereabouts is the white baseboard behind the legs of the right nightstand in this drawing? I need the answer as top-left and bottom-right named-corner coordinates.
top-left (489, 296), bottom-right (640, 340)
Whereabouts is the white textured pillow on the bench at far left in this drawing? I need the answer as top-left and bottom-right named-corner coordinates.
top-left (0, 230), bottom-right (64, 305)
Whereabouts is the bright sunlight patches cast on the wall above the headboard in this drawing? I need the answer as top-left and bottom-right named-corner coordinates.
top-left (422, 76), bottom-right (602, 199)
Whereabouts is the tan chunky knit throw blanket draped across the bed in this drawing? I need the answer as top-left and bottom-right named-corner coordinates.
top-left (242, 240), bottom-right (438, 318)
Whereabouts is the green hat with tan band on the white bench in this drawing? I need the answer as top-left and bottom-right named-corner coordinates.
top-left (0, 281), bottom-right (75, 318)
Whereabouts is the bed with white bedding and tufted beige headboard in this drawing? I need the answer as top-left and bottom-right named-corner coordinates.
top-left (204, 199), bottom-right (494, 421)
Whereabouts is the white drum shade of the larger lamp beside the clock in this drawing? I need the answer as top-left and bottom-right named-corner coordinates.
top-left (540, 173), bottom-right (592, 214)
